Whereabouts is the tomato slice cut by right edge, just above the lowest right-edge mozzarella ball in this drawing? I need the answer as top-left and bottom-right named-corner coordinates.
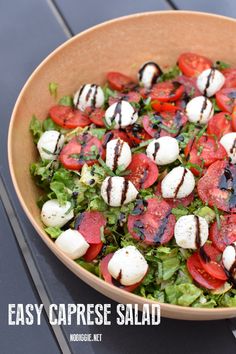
top-left (209, 214), bottom-right (236, 252)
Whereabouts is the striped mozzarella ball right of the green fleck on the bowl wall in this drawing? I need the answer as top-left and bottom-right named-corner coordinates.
top-left (73, 84), bottom-right (105, 111)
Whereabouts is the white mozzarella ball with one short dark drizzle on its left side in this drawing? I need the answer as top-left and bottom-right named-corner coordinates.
top-left (146, 136), bottom-right (179, 165)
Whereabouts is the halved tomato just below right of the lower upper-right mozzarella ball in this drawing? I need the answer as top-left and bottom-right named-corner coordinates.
top-left (207, 112), bottom-right (232, 139)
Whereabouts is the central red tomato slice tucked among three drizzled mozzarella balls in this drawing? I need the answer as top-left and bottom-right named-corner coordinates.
top-left (125, 154), bottom-right (158, 190)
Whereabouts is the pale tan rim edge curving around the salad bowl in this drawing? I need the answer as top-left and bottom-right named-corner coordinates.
top-left (8, 10), bottom-right (236, 319)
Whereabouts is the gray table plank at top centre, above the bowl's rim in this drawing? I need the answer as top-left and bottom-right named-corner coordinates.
top-left (55, 0), bottom-right (171, 33)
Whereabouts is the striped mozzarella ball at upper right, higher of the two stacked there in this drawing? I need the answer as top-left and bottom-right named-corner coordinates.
top-left (197, 68), bottom-right (225, 97)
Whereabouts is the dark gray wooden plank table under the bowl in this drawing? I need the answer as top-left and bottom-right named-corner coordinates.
top-left (0, 0), bottom-right (236, 354)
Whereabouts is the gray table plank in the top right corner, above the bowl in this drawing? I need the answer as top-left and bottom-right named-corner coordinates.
top-left (172, 0), bottom-right (236, 17)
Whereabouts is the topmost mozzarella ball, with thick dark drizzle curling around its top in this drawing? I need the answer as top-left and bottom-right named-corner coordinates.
top-left (138, 61), bottom-right (162, 89)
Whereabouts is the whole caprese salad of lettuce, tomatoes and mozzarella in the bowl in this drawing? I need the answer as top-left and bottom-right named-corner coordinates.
top-left (30, 53), bottom-right (236, 308)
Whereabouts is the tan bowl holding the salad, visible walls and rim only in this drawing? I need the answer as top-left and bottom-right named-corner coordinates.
top-left (9, 11), bottom-right (236, 319)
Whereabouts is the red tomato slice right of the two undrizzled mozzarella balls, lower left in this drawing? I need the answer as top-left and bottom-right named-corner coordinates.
top-left (75, 211), bottom-right (106, 244)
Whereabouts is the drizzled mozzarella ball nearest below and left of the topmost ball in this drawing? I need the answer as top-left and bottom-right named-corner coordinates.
top-left (105, 100), bottom-right (138, 129)
